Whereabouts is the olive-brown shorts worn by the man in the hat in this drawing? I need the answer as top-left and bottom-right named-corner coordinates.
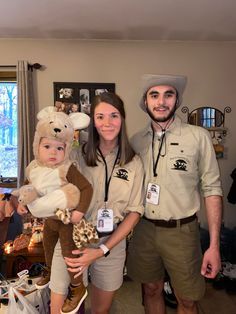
top-left (127, 219), bottom-right (205, 301)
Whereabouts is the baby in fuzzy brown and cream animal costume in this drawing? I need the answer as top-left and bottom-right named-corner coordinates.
top-left (13, 107), bottom-right (95, 314)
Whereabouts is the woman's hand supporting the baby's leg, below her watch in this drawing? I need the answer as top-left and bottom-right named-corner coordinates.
top-left (65, 248), bottom-right (103, 278)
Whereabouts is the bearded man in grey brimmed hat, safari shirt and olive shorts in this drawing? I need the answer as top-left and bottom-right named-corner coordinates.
top-left (127, 75), bottom-right (222, 314)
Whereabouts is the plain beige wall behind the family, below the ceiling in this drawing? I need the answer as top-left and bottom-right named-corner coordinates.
top-left (0, 39), bottom-right (236, 227)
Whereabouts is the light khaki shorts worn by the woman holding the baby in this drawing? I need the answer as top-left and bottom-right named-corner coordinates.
top-left (49, 237), bottom-right (126, 295)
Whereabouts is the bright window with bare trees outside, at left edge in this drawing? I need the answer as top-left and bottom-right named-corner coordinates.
top-left (0, 71), bottom-right (17, 182)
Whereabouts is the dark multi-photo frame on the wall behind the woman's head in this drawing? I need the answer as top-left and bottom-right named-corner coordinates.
top-left (53, 82), bottom-right (115, 147)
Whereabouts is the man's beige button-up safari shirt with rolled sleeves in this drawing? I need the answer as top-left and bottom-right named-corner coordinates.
top-left (131, 116), bottom-right (222, 220)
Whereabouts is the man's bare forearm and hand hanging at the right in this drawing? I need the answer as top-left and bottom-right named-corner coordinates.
top-left (201, 195), bottom-right (222, 278)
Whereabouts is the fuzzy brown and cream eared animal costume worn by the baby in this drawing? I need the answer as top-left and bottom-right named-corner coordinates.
top-left (13, 107), bottom-right (98, 312)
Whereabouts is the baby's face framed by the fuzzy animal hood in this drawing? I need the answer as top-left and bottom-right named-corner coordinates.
top-left (39, 137), bottom-right (65, 167)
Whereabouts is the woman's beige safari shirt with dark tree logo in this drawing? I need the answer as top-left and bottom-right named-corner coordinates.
top-left (73, 149), bottom-right (144, 225)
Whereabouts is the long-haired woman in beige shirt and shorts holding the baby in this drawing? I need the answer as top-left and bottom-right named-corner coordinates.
top-left (51, 92), bottom-right (143, 314)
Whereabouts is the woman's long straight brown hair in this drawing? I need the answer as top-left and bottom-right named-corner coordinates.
top-left (83, 92), bottom-right (135, 167)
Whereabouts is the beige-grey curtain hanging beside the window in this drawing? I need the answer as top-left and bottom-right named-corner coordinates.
top-left (17, 61), bottom-right (35, 187)
